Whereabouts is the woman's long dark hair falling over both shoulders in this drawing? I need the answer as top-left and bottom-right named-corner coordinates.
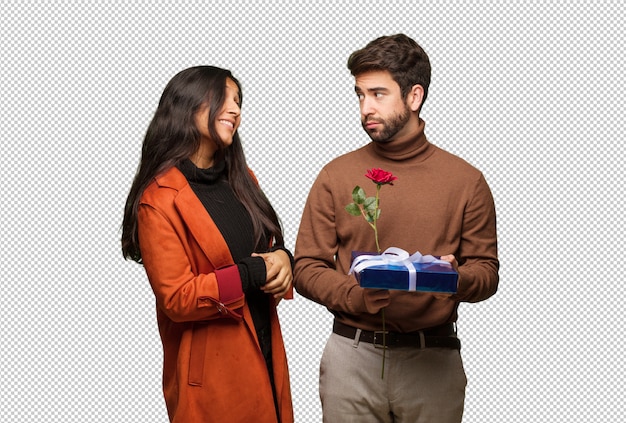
top-left (122, 66), bottom-right (284, 263)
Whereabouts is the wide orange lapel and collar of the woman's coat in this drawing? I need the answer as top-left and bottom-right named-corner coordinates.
top-left (156, 167), bottom-right (234, 269)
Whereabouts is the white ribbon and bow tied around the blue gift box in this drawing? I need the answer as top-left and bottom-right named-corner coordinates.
top-left (348, 247), bottom-right (451, 291)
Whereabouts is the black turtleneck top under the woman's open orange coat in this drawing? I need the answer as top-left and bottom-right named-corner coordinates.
top-left (177, 159), bottom-right (272, 377)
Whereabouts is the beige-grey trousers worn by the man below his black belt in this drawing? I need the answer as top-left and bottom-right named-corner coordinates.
top-left (319, 333), bottom-right (467, 423)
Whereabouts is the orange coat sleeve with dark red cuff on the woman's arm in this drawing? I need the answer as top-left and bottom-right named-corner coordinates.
top-left (138, 203), bottom-right (245, 322)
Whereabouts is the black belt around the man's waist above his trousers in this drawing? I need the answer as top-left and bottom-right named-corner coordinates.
top-left (333, 320), bottom-right (461, 350)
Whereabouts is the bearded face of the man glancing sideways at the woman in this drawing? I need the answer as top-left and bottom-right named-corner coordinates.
top-left (354, 71), bottom-right (411, 143)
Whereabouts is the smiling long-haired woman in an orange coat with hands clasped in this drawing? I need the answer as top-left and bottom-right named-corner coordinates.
top-left (122, 66), bottom-right (293, 423)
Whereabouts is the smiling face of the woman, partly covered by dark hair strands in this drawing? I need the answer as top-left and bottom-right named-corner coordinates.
top-left (195, 78), bottom-right (241, 149)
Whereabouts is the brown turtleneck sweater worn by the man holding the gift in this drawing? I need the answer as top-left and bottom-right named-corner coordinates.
top-left (294, 120), bottom-right (499, 332)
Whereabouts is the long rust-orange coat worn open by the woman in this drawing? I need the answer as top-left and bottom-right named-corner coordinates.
top-left (138, 168), bottom-right (293, 423)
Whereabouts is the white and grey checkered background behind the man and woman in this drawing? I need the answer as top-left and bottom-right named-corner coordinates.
top-left (0, 0), bottom-right (626, 422)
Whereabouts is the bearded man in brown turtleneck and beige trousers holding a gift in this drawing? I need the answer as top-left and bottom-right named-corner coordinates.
top-left (294, 34), bottom-right (499, 423)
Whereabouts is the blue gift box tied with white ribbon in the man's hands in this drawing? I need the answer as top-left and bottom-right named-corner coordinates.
top-left (352, 251), bottom-right (459, 294)
